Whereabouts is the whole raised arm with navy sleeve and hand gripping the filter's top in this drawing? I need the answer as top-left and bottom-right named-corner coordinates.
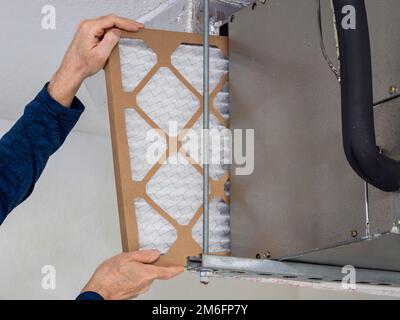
top-left (0, 15), bottom-right (143, 224)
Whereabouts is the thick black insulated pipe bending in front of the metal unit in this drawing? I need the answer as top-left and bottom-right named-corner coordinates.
top-left (333, 0), bottom-right (400, 192)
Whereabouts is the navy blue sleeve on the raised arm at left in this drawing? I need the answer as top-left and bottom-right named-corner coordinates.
top-left (0, 84), bottom-right (85, 225)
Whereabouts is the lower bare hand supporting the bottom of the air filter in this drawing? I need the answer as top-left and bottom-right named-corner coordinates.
top-left (82, 250), bottom-right (184, 300)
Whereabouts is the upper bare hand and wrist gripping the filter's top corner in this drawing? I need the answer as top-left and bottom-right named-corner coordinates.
top-left (48, 15), bottom-right (144, 107)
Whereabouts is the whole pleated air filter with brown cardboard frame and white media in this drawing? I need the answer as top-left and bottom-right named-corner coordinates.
top-left (106, 30), bottom-right (230, 265)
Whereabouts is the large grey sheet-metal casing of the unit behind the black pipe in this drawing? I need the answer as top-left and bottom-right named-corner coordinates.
top-left (230, 0), bottom-right (400, 258)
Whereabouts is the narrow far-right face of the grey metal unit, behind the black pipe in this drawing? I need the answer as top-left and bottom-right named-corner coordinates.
top-left (366, 0), bottom-right (400, 234)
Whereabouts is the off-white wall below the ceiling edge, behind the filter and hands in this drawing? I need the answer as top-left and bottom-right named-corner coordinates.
top-left (0, 120), bottom-right (297, 299)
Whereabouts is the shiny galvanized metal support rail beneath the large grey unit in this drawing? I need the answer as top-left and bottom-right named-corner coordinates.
top-left (188, 255), bottom-right (400, 296)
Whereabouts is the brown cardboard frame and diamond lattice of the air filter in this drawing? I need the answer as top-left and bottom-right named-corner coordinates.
top-left (105, 29), bottom-right (229, 266)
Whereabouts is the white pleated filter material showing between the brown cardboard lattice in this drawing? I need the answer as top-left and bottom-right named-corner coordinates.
top-left (119, 39), bottom-right (230, 253)
